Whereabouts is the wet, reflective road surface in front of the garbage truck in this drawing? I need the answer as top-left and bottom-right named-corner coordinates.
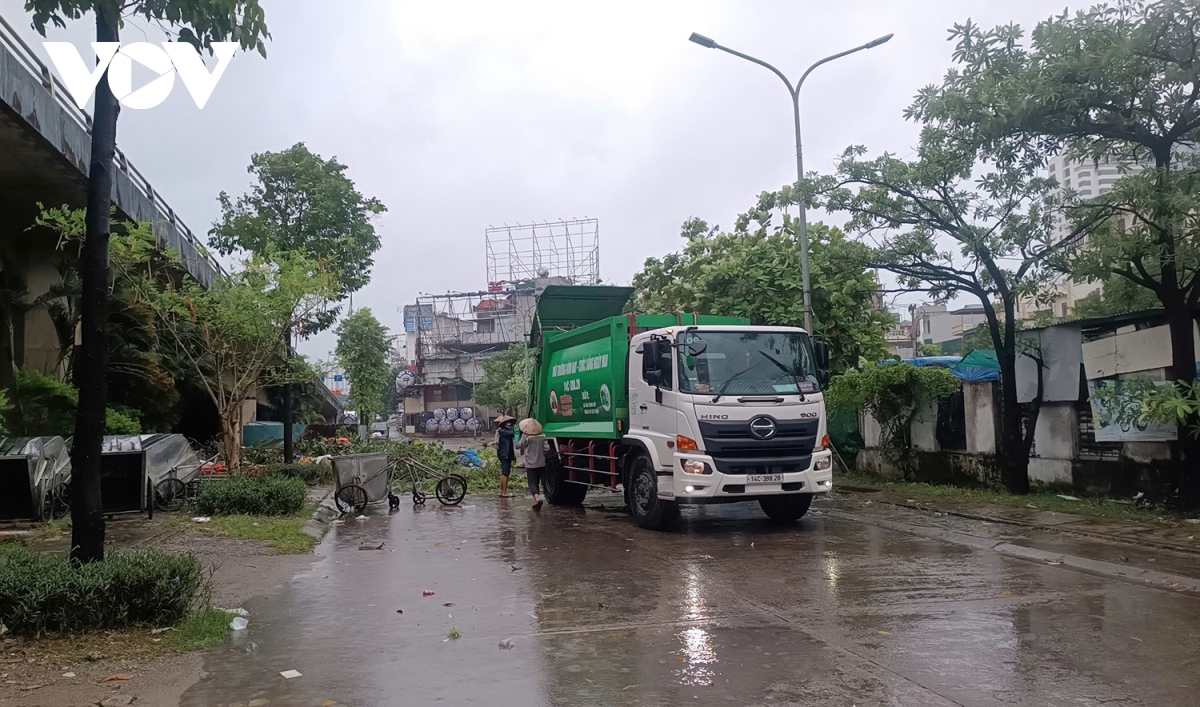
top-left (181, 496), bottom-right (1200, 707)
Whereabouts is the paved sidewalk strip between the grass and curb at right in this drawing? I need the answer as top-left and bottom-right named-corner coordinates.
top-left (838, 486), bottom-right (1200, 555)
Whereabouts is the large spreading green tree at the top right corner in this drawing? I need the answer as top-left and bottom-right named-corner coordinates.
top-left (911, 0), bottom-right (1200, 505)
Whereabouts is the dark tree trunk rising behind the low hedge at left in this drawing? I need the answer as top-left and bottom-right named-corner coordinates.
top-left (71, 11), bottom-right (120, 563)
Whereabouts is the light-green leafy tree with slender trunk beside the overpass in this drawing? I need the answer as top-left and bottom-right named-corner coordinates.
top-left (125, 248), bottom-right (337, 468)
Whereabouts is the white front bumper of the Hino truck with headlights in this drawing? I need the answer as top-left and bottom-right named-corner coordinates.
top-left (659, 449), bottom-right (833, 504)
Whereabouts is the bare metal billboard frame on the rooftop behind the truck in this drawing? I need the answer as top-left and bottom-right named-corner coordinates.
top-left (486, 218), bottom-right (600, 288)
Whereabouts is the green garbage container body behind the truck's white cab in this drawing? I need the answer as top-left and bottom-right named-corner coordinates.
top-left (533, 286), bottom-right (750, 439)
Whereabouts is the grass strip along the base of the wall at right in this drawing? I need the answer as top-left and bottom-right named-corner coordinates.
top-left (834, 474), bottom-right (1183, 526)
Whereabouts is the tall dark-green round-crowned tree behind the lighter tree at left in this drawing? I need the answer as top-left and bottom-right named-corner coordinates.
top-left (209, 143), bottom-right (388, 334)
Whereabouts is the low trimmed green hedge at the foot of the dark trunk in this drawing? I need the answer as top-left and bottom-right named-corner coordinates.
top-left (0, 549), bottom-right (209, 636)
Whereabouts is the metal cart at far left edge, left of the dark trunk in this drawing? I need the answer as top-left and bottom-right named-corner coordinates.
top-left (0, 436), bottom-right (71, 521)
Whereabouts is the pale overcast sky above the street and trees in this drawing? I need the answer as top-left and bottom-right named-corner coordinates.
top-left (0, 0), bottom-right (1080, 358)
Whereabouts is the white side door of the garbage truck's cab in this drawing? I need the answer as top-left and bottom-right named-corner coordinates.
top-left (629, 338), bottom-right (678, 471)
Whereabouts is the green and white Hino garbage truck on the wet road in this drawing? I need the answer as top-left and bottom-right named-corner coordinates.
top-left (529, 284), bottom-right (833, 529)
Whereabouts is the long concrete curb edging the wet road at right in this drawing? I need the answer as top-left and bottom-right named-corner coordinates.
top-left (824, 510), bottom-right (1200, 594)
